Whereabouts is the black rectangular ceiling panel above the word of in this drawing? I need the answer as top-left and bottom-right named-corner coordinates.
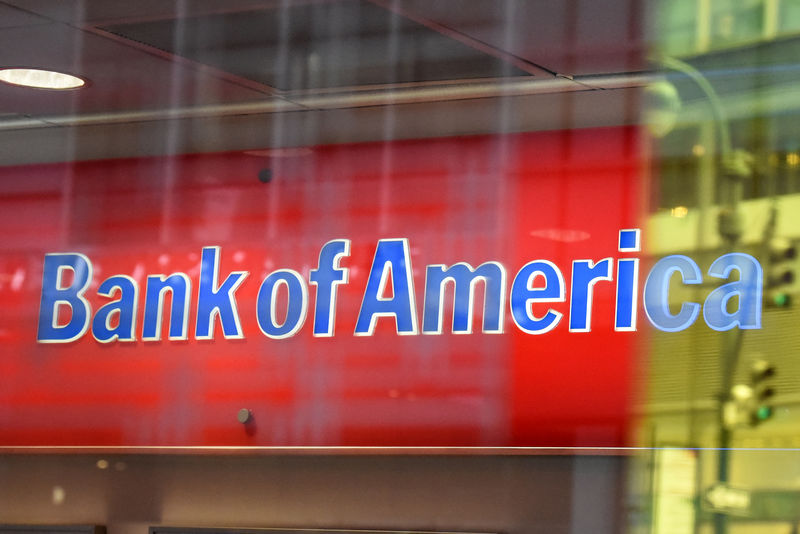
top-left (103, 1), bottom-right (530, 91)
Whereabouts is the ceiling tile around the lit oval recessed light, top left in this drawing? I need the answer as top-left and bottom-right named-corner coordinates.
top-left (0, 24), bottom-right (274, 115)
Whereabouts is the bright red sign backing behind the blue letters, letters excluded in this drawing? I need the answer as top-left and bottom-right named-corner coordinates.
top-left (0, 128), bottom-right (643, 447)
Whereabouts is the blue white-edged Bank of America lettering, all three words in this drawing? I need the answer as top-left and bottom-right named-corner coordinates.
top-left (38, 229), bottom-right (763, 343)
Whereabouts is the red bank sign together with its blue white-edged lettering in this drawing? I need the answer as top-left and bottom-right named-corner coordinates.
top-left (0, 127), bottom-right (664, 447)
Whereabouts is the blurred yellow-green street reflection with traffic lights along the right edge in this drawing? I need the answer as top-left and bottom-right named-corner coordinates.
top-left (640, 1), bottom-right (800, 532)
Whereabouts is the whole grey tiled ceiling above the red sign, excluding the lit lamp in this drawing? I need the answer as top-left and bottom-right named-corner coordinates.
top-left (0, 0), bottom-right (645, 165)
